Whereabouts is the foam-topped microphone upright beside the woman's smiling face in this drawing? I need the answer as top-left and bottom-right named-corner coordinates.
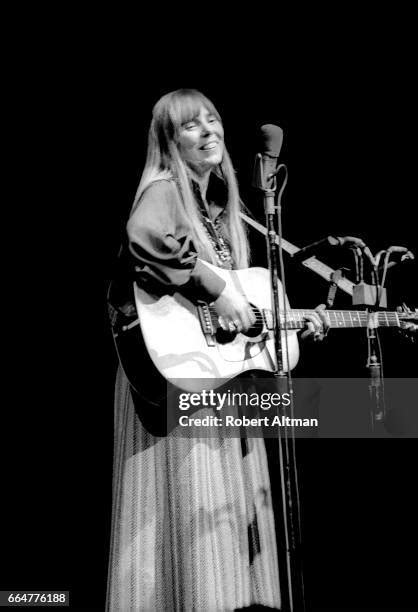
top-left (252, 123), bottom-right (283, 191)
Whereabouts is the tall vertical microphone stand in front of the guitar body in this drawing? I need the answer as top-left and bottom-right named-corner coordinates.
top-left (256, 155), bottom-right (305, 612)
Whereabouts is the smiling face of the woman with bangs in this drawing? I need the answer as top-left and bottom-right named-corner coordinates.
top-left (177, 106), bottom-right (224, 174)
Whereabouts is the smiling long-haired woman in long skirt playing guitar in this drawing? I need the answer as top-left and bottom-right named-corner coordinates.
top-left (108, 90), bottom-right (322, 610)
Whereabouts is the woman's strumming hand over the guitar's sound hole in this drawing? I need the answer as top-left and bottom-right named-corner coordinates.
top-left (213, 284), bottom-right (256, 332)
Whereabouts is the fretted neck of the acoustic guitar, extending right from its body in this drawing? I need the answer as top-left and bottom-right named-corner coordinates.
top-left (280, 309), bottom-right (402, 329)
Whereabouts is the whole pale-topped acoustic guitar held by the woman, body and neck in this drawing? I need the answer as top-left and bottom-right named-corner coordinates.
top-left (115, 262), bottom-right (417, 392)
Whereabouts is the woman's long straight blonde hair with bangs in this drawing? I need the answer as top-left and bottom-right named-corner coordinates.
top-left (132, 89), bottom-right (249, 268)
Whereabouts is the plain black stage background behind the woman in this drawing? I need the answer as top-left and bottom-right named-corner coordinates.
top-left (0, 22), bottom-right (418, 610)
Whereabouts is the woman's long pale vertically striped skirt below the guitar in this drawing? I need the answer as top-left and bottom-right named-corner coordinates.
top-left (107, 371), bottom-right (280, 612)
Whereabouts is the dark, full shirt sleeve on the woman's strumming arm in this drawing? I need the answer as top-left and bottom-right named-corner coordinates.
top-left (127, 180), bottom-right (225, 302)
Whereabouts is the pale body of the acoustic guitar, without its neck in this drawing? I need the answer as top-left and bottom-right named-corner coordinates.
top-left (131, 262), bottom-right (299, 392)
